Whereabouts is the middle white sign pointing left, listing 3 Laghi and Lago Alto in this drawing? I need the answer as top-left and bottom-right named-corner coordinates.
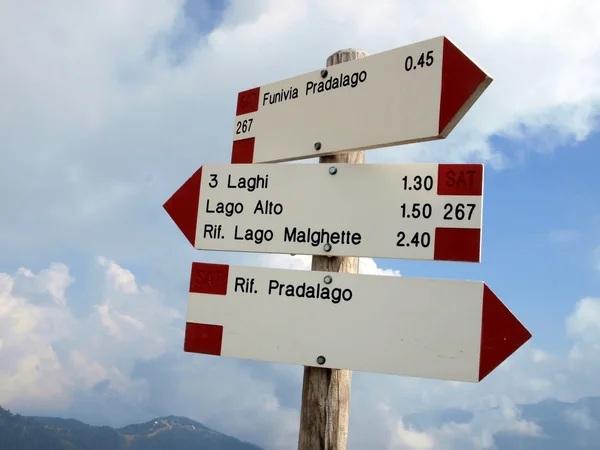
top-left (164, 164), bottom-right (483, 262)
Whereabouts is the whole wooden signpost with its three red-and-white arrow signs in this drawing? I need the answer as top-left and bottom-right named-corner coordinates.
top-left (163, 36), bottom-right (531, 450)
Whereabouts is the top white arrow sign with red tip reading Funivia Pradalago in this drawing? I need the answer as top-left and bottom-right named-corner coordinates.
top-left (231, 36), bottom-right (492, 164)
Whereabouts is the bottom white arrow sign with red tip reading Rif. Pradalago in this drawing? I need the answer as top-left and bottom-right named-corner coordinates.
top-left (184, 263), bottom-right (531, 382)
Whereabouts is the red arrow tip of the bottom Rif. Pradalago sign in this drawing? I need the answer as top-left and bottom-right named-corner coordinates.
top-left (479, 284), bottom-right (531, 381)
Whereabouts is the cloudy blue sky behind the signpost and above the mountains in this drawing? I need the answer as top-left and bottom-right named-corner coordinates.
top-left (0, 0), bottom-right (600, 449)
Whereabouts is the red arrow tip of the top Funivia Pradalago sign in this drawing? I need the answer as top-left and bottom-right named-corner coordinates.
top-left (439, 38), bottom-right (492, 137)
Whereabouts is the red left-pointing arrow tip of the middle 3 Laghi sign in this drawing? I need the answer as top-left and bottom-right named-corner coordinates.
top-left (163, 167), bottom-right (202, 245)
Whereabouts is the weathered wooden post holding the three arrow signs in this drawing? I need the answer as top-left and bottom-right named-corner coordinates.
top-left (298, 48), bottom-right (368, 450)
